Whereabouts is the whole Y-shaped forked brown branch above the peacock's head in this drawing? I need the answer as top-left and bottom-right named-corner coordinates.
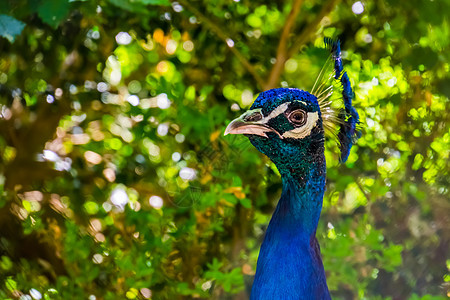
top-left (264, 0), bottom-right (339, 90)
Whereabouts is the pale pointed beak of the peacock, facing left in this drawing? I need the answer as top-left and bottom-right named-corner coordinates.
top-left (224, 108), bottom-right (280, 137)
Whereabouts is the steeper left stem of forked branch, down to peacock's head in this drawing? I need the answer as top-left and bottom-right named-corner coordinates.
top-left (263, 0), bottom-right (303, 90)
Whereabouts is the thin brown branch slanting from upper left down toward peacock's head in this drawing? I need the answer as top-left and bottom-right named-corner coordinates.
top-left (178, 0), bottom-right (264, 87)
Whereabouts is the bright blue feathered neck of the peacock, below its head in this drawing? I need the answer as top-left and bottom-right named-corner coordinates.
top-left (250, 153), bottom-right (330, 300)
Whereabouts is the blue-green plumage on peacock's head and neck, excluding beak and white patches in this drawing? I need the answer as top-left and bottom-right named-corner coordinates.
top-left (243, 88), bottom-right (330, 300)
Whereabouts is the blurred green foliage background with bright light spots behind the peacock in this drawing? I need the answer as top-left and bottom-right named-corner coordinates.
top-left (0, 0), bottom-right (450, 300)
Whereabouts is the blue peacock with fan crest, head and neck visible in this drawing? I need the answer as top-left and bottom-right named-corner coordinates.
top-left (225, 39), bottom-right (359, 300)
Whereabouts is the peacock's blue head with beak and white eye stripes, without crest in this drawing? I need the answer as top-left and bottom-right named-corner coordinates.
top-left (225, 88), bottom-right (324, 174)
